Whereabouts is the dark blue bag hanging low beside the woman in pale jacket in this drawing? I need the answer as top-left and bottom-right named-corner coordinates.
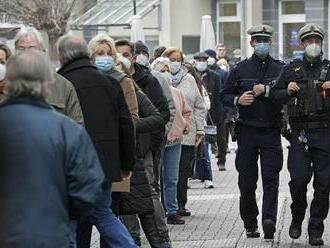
top-left (192, 144), bottom-right (211, 180)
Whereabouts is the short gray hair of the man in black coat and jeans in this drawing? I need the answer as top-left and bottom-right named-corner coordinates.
top-left (57, 34), bottom-right (89, 65)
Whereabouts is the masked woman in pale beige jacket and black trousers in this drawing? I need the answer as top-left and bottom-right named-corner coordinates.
top-left (162, 47), bottom-right (206, 216)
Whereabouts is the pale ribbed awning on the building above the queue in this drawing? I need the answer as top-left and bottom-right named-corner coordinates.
top-left (71, 0), bottom-right (160, 29)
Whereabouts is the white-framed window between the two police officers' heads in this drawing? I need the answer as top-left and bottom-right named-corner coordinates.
top-left (279, 0), bottom-right (306, 60)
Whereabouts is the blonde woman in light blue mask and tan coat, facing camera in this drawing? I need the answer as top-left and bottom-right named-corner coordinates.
top-left (88, 34), bottom-right (139, 122)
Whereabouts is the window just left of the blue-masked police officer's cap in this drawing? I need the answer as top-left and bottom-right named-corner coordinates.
top-left (217, 0), bottom-right (242, 57)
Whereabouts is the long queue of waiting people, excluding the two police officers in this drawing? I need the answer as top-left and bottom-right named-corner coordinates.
top-left (0, 27), bottom-right (232, 248)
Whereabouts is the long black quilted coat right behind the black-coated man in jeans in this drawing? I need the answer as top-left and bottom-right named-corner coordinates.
top-left (120, 91), bottom-right (164, 214)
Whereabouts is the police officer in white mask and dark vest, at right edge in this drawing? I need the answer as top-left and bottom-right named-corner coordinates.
top-left (271, 24), bottom-right (330, 245)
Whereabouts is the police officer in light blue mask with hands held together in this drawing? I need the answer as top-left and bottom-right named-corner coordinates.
top-left (220, 25), bottom-right (284, 239)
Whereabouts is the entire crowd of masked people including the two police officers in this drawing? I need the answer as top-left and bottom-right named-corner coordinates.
top-left (0, 21), bottom-right (330, 248)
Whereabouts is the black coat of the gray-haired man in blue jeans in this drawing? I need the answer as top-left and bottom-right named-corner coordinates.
top-left (58, 57), bottom-right (135, 182)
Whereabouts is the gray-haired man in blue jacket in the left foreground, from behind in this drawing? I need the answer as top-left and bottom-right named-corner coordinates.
top-left (0, 50), bottom-right (104, 248)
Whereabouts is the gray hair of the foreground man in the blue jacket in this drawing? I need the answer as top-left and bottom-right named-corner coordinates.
top-left (5, 49), bottom-right (54, 98)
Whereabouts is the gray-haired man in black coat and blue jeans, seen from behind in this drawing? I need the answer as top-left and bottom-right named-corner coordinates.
top-left (58, 35), bottom-right (136, 247)
